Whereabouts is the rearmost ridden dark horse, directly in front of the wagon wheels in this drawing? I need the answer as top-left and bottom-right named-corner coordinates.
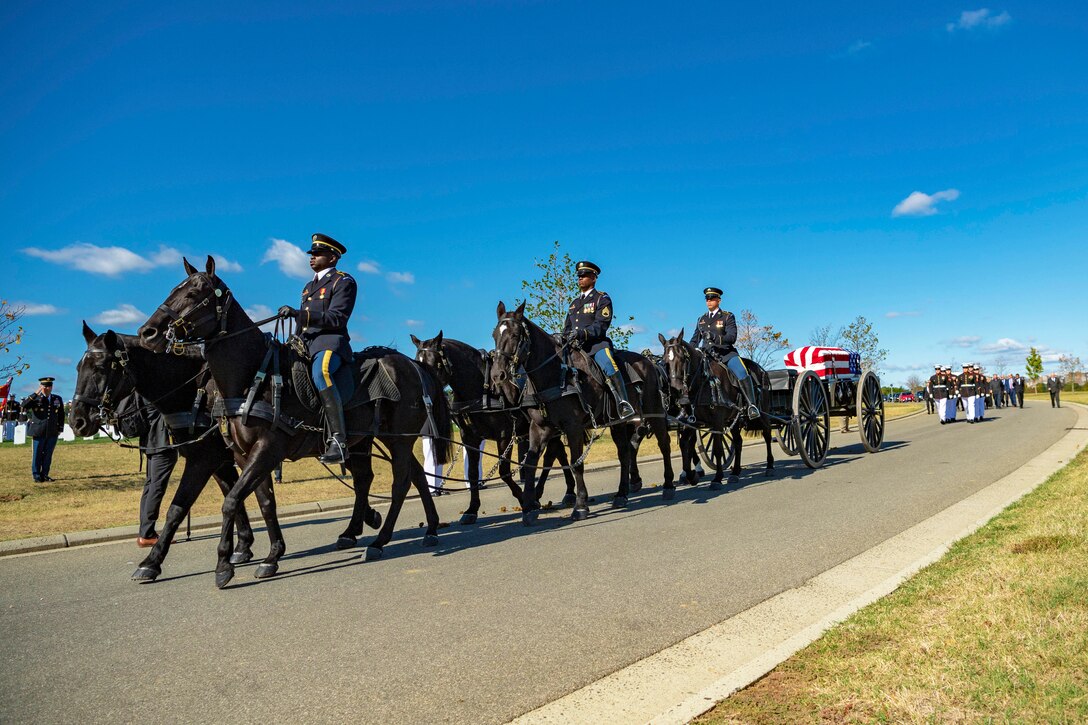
top-left (657, 330), bottom-right (775, 491)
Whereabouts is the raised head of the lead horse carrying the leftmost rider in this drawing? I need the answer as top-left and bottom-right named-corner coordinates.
top-left (138, 255), bottom-right (232, 353)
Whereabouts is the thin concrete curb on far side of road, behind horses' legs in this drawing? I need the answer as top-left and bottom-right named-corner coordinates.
top-left (0, 408), bottom-right (925, 557)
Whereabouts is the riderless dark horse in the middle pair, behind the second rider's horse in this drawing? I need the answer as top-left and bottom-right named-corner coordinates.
top-left (411, 330), bottom-right (574, 515)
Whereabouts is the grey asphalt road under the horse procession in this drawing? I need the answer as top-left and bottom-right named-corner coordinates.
top-left (0, 403), bottom-right (1075, 723)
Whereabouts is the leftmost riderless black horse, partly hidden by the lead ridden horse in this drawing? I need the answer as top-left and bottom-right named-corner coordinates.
top-left (71, 322), bottom-right (283, 582)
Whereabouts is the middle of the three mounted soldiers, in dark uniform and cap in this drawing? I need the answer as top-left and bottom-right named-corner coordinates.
top-left (562, 261), bottom-right (634, 420)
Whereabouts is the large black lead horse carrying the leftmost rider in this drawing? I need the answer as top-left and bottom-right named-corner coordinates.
top-left (138, 255), bottom-right (450, 589)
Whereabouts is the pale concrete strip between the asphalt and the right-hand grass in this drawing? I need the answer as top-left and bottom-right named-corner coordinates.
top-left (511, 403), bottom-right (1088, 725)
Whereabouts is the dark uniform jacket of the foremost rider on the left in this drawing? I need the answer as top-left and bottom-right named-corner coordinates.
top-left (295, 269), bottom-right (357, 363)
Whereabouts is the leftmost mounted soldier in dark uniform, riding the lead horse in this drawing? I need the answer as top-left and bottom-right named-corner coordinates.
top-left (280, 234), bottom-right (357, 464)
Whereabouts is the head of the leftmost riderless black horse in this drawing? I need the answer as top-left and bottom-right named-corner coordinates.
top-left (71, 322), bottom-right (135, 437)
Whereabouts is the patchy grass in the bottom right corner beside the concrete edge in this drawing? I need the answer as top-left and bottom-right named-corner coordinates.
top-left (696, 428), bottom-right (1088, 725)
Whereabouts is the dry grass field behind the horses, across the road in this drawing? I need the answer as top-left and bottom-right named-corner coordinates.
top-left (0, 403), bottom-right (922, 541)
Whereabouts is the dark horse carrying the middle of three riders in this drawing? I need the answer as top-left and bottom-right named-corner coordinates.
top-left (491, 302), bottom-right (676, 525)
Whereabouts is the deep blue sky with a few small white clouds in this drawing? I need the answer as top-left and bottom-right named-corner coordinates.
top-left (0, 2), bottom-right (1088, 396)
